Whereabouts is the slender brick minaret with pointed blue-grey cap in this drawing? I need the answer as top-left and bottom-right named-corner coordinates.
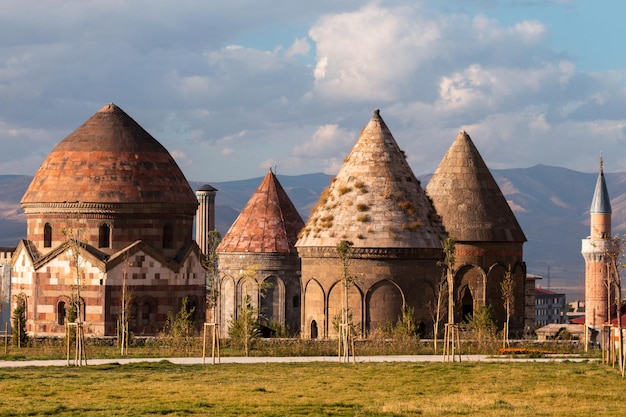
top-left (581, 157), bottom-right (611, 329)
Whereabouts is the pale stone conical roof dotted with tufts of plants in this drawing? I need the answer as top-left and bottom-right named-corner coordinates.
top-left (296, 110), bottom-right (446, 248)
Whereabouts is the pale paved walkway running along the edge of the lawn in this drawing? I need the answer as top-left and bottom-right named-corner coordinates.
top-left (0, 355), bottom-right (589, 368)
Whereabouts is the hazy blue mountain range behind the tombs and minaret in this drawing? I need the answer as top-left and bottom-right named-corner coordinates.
top-left (0, 165), bottom-right (626, 300)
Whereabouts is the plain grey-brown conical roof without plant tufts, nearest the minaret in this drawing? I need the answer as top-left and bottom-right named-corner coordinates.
top-left (426, 131), bottom-right (526, 242)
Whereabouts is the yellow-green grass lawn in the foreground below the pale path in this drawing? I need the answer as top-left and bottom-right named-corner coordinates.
top-left (0, 362), bottom-right (626, 416)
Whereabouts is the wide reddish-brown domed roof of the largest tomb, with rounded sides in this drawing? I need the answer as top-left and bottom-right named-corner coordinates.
top-left (22, 104), bottom-right (197, 208)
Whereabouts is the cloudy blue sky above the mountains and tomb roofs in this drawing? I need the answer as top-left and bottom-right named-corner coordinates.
top-left (0, 0), bottom-right (626, 183)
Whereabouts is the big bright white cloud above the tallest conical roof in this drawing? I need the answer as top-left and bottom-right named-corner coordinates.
top-left (309, 5), bottom-right (439, 100)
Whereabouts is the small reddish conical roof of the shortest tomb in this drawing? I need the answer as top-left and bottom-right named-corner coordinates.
top-left (217, 170), bottom-right (304, 253)
